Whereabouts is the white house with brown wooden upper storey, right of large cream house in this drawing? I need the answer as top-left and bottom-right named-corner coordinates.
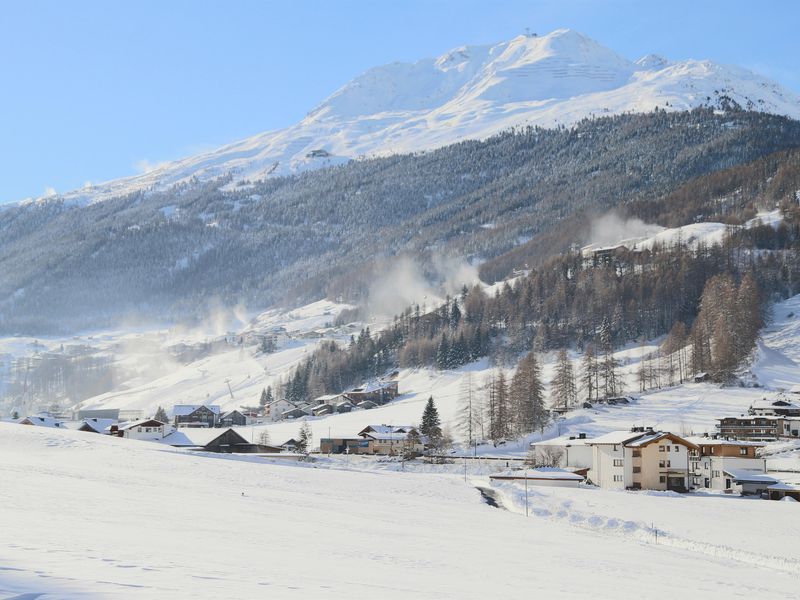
top-left (686, 437), bottom-right (766, 494)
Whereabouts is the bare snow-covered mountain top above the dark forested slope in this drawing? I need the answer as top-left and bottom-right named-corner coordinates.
top-left (48, 29), bottom-right (800, 202)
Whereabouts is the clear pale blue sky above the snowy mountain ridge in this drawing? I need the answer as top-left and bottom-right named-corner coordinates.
top-left (0, 0), bottom-right (800, 203)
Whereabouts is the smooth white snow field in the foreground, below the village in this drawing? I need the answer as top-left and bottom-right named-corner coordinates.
top-left (0, 424), bottom-right (797, 598)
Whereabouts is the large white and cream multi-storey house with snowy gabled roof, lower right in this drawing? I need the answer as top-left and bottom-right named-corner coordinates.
top-left (586, 427), bottom-right (697, 492)
